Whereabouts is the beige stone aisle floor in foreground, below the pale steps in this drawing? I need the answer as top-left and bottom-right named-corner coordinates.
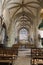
top-left (13, 57), bottom-right (31, 65)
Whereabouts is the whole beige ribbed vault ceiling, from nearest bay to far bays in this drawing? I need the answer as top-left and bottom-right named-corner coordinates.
top-left (2, 0), bottom-right (43, 29)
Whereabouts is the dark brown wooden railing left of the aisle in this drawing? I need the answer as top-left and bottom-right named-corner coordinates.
top-left (0, 48), bottom-right (18, 60)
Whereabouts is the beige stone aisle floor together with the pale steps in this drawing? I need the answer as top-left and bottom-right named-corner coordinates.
top-left (13, 49), bottom-right (31, 65)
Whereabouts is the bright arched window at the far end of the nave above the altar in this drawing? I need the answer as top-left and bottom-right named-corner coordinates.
top-left (19, 28), bottom-right (28, 42)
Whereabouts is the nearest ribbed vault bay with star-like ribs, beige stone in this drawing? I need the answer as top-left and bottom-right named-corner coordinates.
top-left (3, 0), bottom-right (40, 17)
